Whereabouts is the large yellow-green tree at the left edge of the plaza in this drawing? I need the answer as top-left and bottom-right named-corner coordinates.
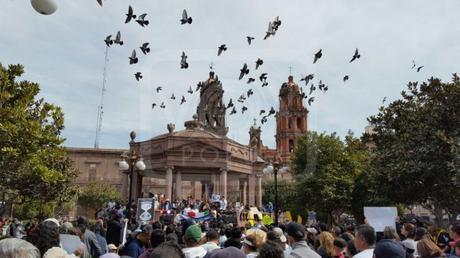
top-left (0, 64), bottom-right (77, 217)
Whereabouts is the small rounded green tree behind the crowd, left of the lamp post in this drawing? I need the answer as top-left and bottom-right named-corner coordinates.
top-left (78, 182), bottom-right (122, 210)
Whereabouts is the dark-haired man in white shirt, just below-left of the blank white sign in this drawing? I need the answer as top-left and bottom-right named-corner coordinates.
top-left (353, 224), bottom-right (376, 258)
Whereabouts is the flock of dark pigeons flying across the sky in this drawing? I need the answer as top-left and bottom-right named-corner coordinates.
top-left (97, 0), bottom-right (424, 124)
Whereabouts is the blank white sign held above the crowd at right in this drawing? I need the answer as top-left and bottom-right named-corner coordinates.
top-left (364, 207), bottom-right (398, 232)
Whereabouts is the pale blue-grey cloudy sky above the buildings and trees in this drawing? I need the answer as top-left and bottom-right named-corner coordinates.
top-left (0, 0), bottom-right (460, 148)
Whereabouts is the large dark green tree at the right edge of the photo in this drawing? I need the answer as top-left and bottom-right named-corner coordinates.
top-left (366, 74), bottom-right (460, 223)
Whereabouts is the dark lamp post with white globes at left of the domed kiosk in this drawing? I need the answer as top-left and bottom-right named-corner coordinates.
top-left (119, 137), bottom-right (145, 221)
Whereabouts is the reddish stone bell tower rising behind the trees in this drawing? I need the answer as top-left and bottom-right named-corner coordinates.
top-left (275, 76), bottom-right (308, 163)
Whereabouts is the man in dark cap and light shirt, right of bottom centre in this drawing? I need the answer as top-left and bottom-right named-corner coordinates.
top-left (286, 222), bottom-right (321, 258)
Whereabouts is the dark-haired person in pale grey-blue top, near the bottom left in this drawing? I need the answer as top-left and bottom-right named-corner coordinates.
top-left (59, 222), bottom-right (89, 258)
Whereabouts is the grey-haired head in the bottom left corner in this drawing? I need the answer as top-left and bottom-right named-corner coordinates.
top-left (0, 238), bottom-right (40, 258)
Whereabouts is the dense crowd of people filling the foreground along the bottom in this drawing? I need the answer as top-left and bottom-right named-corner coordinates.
top-left (0, 206), bottom-right (460, 258)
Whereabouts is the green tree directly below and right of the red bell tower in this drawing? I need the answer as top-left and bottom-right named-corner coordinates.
top-left (291, 132), bottom-right (370, 224)
